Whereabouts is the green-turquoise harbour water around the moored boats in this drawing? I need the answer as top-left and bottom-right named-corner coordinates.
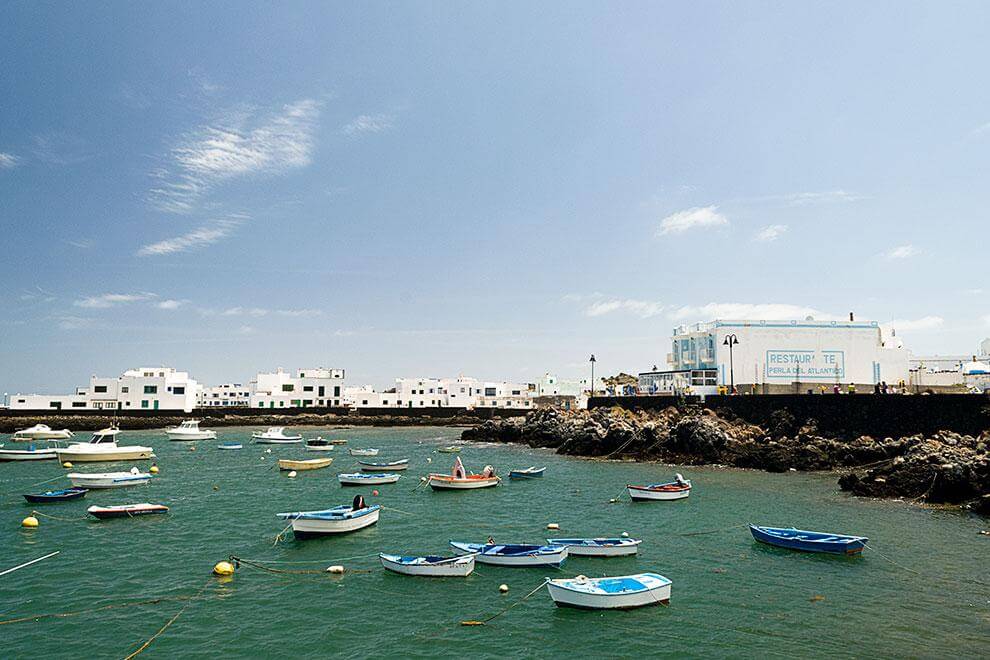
top-left (0, 428), bottom-right (990, 658)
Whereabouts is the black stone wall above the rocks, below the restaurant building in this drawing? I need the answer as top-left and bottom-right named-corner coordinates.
top-left (588, 393), bottom-right (990, 438)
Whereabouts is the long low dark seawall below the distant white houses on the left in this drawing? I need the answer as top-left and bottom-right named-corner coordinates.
top-left (0, 408), bottom-right (527, 433)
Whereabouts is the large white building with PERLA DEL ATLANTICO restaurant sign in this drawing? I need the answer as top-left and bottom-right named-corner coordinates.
top-left (639, 315), bottom-right (908, 394)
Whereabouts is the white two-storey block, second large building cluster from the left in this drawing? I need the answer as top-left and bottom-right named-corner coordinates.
top-left (251, 367), bottom-right (344, 408)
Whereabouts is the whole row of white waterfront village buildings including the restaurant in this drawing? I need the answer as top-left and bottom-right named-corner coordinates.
top-left (4, 314), bottom-right (990, 412)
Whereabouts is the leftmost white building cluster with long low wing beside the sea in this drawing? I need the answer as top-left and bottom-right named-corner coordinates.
top-left (10, 367), bottom-right (200, 412)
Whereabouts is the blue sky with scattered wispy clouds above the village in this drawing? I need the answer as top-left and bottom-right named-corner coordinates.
top-left (0, 1), bottom-right (990, 393)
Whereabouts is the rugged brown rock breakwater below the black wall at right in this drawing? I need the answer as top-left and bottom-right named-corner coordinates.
top-left (462, 407), bottom-right (990, 512)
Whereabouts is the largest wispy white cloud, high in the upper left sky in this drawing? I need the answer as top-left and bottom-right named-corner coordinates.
top-left (149, 99), bottom-right (321, 213)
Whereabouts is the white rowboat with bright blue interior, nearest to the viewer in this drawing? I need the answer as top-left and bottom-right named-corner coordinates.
top-left (547, 573), bottom-right (672, 610)
